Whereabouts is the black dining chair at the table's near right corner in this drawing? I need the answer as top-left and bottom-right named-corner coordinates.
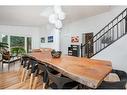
top-left (98, 69), bottom-right (127, 89)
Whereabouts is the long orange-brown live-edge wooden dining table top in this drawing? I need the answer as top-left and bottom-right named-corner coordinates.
top-left (28, 52), bottom-right (112, 88)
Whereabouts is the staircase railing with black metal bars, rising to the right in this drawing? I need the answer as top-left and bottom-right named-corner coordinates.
top-left (81, 8), bottom-right (127, 58)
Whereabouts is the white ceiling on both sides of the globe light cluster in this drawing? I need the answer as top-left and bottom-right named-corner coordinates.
top-left (0, 6), bottom-right (111, 26)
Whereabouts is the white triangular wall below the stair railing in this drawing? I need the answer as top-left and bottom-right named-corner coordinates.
top-left (93, 35), bottom-right (127, 72)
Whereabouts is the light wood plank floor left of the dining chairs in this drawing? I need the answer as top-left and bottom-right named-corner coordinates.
top-left (0, 62), bottom-right (42, 89)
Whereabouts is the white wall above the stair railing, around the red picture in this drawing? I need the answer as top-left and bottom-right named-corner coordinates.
top-left (61, 6), bottom-right (126, 54)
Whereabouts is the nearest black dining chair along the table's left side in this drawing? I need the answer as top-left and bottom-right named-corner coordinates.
top-left (45, 67), bottom-right (79, 89)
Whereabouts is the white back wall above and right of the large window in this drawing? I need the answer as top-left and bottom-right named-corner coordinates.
top-left (0, 25), bottom-right (39, 49)
